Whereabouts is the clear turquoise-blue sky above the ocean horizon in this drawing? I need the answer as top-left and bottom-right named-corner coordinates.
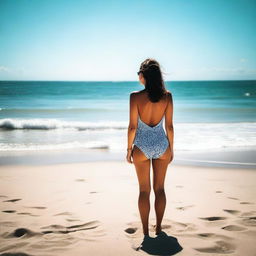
top-left (0, 0), bottom-right (256, 81)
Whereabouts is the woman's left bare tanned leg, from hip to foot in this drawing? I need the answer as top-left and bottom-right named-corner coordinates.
top-left (132, 146), bottom-right (151, 235)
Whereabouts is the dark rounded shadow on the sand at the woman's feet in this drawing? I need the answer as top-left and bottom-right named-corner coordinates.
top-left (137, 231), bottom-right (182, 256)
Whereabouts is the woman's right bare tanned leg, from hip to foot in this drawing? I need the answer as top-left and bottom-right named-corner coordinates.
top-left (152, 148), bottom-right (171, 235)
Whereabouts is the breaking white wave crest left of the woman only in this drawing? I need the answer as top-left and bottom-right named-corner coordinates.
top-left (0, 118), bottom-right (128, 131)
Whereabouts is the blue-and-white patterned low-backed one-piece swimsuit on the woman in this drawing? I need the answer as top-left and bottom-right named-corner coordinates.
top-left (133, 116), bottom-right (169, 159)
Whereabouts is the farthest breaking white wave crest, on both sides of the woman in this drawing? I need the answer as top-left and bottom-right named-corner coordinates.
top-left (0, 118), bottom-right (256, 131)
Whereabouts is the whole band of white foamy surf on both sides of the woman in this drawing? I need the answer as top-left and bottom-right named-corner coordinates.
top-left (0, 119), bottom-right (256, 152)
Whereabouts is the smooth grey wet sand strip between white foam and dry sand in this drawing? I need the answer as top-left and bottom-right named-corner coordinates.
top-left (0, 149), bottom-right (256, 170)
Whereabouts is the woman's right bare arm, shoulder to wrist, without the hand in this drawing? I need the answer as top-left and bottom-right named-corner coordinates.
top-left (165, 92), bottom-right (174, 150)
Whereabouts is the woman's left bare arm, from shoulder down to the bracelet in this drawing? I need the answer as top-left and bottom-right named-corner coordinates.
top-left (127, 92), bottom-right (138, 149)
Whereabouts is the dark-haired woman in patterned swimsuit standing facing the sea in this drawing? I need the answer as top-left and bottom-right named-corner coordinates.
top-left (126, 59), bottom-right (174, 236)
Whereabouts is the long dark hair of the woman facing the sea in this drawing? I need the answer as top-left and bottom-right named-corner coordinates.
top-left (139, 58), bottom-right (167, 102)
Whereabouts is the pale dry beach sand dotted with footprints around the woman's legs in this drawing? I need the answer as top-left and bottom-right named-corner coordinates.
top-left (0, 161), bottom-right (256, 256)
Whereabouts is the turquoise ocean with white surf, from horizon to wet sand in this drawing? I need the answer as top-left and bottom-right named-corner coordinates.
top-left (0, 81), bottom-right (256, 158)
